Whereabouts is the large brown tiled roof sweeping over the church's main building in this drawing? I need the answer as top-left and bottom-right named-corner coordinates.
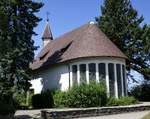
top-left (31, 24), bottom-right (127, 70)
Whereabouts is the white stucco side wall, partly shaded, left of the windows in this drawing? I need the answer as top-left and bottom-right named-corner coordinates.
top-left (31, 65), bottom-right (69, 93)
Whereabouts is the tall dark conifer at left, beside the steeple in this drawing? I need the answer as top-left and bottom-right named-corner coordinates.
top-left (0, 0), bottom-right (43, 104)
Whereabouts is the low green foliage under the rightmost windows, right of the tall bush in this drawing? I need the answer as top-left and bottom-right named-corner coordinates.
top-left (107, 97), bottom-right (138, 106)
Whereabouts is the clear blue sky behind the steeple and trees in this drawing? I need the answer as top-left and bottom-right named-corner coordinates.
top-left (33, 0), bottom-right (150, 54)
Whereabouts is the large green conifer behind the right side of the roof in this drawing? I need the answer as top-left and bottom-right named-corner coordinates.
top-left (96, 0), bottom-right (150, 79)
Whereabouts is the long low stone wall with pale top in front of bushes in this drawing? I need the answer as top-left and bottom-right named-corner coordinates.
top-left (41, 105), bottom-right (150, 119)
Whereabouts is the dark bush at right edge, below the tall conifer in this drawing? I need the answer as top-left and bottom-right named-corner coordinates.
top-left (130, 83), bottom-right (150, 101)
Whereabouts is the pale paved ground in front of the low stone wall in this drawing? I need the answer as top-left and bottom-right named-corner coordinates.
top-left (78, 111), bottom-right (150, 119)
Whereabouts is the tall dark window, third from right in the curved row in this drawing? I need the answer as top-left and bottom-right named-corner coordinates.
top-left (108, 63), bottom-right (115, 96)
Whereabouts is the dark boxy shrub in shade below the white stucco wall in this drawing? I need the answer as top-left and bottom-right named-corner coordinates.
top-left (32, 91), bottom-right (54, 109)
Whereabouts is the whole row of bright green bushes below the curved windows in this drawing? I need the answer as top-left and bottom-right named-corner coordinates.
top-left (54, 82), bottom-right (138, 108)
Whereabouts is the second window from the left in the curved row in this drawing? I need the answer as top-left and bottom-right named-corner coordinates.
top-left (80, 64), bottom-right (86, 83)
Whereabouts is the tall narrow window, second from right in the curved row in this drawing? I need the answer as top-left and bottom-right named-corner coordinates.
top-left (116, 64), bottom-right (122, 97)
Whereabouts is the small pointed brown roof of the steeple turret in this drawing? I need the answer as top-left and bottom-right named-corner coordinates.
top-left (42, 22), bottom-right (53, 40)
